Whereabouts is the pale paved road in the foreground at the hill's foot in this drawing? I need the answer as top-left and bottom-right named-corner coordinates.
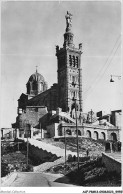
top-left (1, 172), bottom-right (75, 187)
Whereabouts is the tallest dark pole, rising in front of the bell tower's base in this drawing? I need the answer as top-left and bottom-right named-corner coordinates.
top-left (73, 97), bottom-right (79, 170)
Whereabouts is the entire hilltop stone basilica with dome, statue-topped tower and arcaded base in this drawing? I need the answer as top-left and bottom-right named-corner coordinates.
top-left (12, 12), bottom-right (120, 140)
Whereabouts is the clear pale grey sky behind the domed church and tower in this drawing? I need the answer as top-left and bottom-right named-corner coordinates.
top-left (1, 1), bottom-right (122, 127)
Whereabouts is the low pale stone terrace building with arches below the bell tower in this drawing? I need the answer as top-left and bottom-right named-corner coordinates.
top-left (46, 108), bottom-right (120, 141)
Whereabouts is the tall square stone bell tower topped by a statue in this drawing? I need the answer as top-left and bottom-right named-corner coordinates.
top-left (56, 12), bottom-right (82, 118)
